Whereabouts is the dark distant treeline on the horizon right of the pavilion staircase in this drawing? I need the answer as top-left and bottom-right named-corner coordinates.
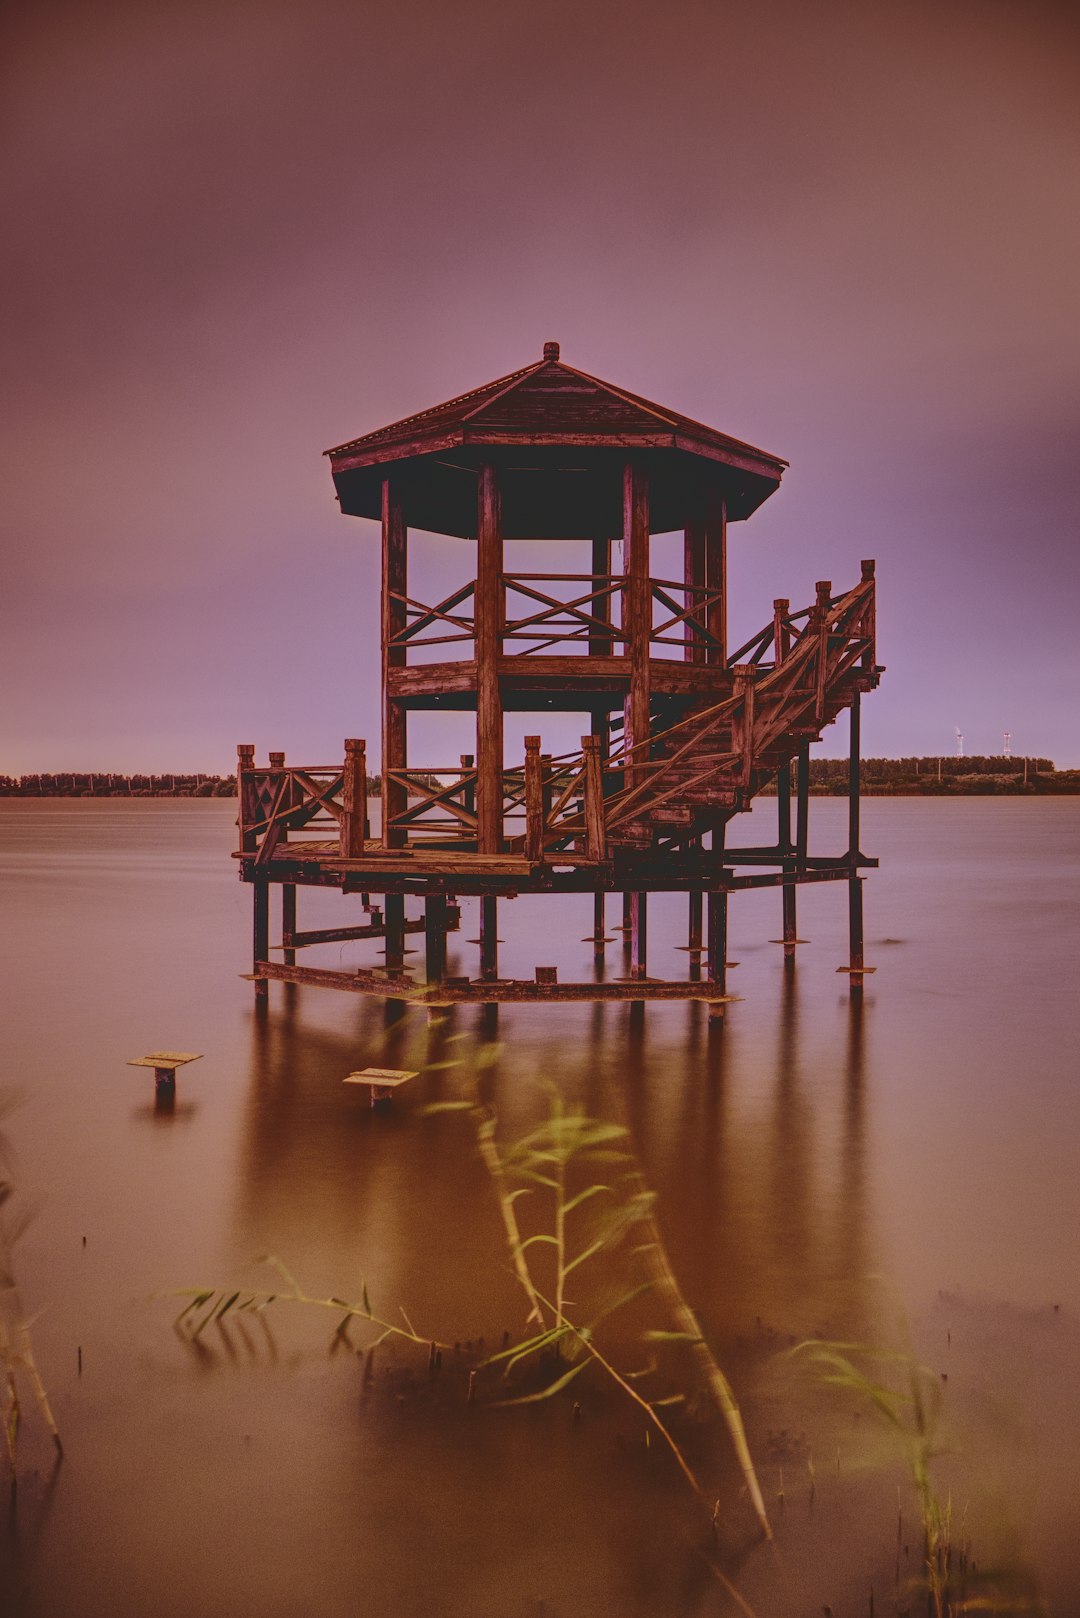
top-left (773, 754), bottom-right (1080, 798)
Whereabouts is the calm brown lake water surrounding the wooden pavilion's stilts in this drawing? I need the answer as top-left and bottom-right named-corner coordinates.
top-left (0, 799), bottom-right (1080, 1618)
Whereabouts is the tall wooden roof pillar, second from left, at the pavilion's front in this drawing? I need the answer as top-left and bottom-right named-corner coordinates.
top-left (476, 463), bottom-right (504, 854)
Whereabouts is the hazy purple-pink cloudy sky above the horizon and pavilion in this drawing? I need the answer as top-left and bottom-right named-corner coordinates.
top-left (0, 0), bottom-right (1080, 773)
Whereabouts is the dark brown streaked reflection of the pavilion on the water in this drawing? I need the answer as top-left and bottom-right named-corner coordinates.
top-left (236, 972), bottom-right (873, 1338)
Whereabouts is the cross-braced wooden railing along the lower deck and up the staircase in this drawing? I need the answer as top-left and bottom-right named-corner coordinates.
top-left (238, 563), bottom-right (878, 866)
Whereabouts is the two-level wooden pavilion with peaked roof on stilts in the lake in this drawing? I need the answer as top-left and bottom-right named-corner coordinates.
top-left (236, 343), bottom-right (881, 1014)
